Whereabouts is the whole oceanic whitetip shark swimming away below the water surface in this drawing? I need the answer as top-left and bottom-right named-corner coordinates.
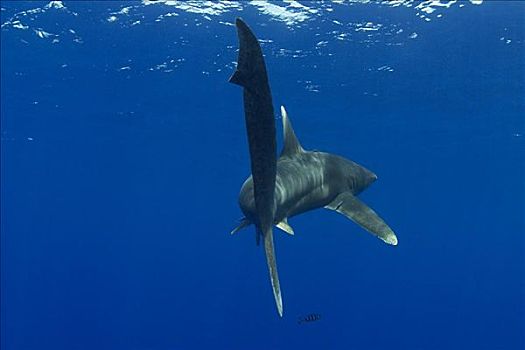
top-left (230, 18), bottom-right (397, 317)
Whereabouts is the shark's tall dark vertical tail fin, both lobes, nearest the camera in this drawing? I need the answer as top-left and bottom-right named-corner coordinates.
top-left (230, 18), bottom-right (283, 316)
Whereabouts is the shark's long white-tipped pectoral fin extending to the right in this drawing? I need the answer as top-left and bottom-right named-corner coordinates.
top-left (325, 192), bottom-right (397, 245)
